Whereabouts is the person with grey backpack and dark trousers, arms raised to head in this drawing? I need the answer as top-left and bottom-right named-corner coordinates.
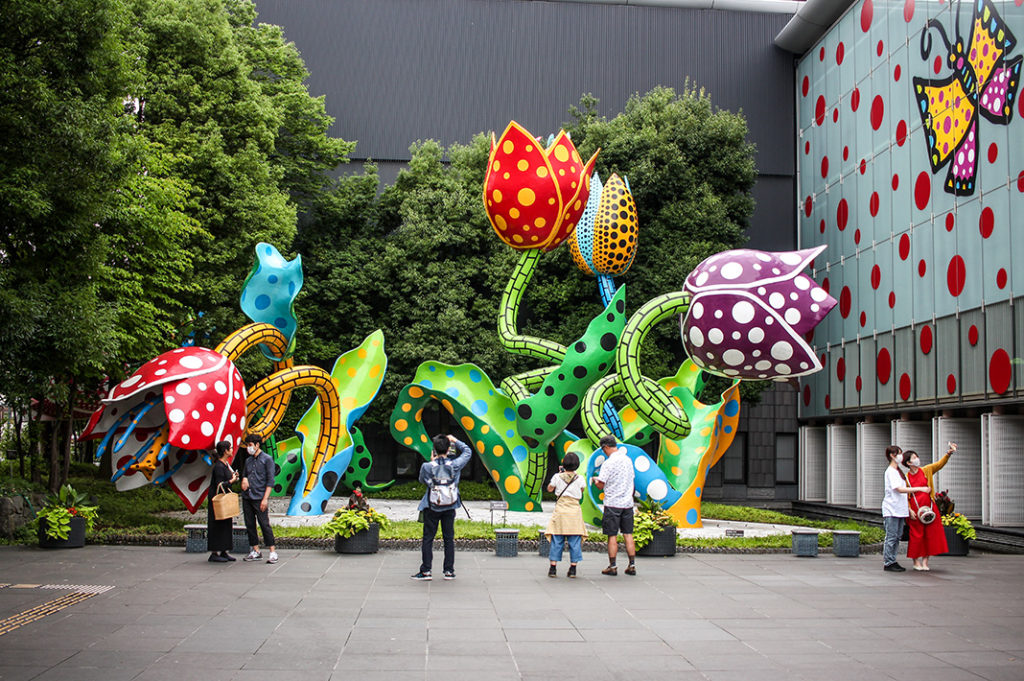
top-left (413, 435), bottom-right (473, 582)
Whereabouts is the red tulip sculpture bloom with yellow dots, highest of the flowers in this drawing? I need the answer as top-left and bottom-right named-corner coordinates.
top-left (483, 121), bottom-right (597, 252)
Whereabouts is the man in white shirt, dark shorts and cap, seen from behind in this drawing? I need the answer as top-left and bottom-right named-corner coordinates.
top-left (594, 435), bottom-right (637, 577)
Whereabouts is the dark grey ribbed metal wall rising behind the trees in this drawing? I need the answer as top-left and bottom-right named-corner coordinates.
top-left (256, 0), bottom-right (796, 250)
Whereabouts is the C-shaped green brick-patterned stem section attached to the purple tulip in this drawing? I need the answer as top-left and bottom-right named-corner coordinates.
top-left (615, 291), bottom-right (690, 439)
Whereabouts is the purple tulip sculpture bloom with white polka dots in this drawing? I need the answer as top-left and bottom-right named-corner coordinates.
top-left (680, 246), bottom-right (836, 381)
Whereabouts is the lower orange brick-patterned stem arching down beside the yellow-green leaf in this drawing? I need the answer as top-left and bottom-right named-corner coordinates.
top-left (248, 366), bottom-right (341, 495)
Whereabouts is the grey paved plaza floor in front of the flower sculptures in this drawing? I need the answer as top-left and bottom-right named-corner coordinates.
top-left (0, 546), bottom-right (1024, 681)
